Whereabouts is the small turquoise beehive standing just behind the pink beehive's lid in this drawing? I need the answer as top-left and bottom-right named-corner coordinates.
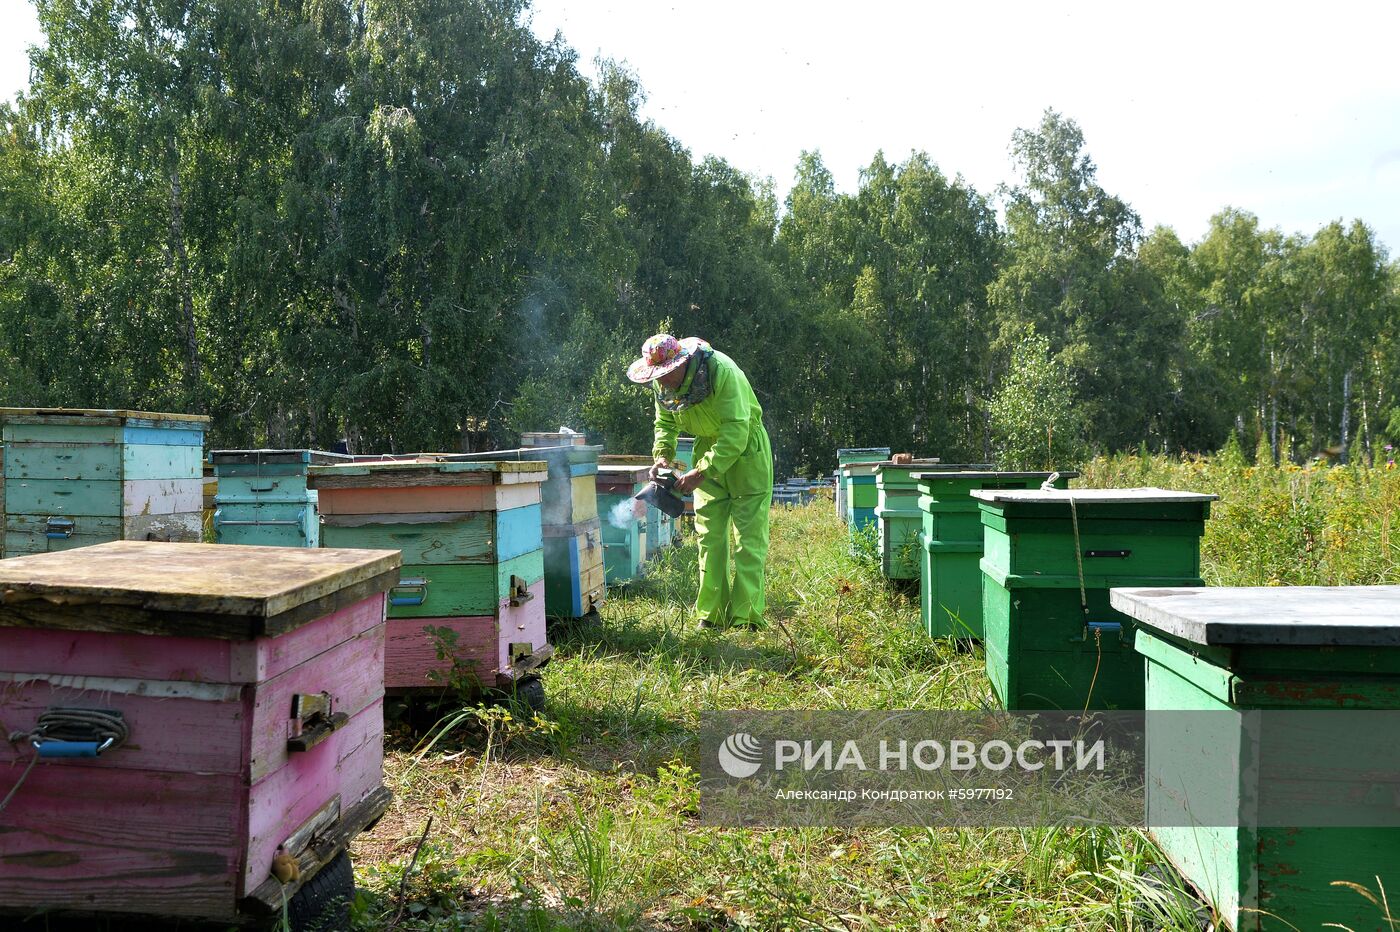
top-left (209, 449), bottom-right (350, 547)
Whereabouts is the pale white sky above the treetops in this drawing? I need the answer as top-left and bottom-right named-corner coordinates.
top-left (0, 0), bottom-right (1400, 255)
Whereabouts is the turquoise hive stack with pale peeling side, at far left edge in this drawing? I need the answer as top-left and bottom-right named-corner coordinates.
top-left (0, 407), bottom-right (209, 557)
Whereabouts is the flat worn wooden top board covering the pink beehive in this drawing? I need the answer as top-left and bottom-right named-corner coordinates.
top-left (0, 540), bottom-right (399, 624)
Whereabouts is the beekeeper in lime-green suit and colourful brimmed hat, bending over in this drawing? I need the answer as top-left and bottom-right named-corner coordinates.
top-left (627, 333), bottom-right (773, 627)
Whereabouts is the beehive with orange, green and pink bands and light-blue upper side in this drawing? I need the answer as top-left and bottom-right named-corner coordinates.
top-left (308, 460), bottom-right (550, 693)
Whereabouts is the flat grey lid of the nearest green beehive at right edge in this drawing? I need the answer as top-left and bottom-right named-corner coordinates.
top-left (1114, 584), bottom-right (1400, 647)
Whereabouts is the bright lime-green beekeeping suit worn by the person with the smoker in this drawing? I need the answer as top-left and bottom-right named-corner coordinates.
top-left (652, 350), bottom-right (773, 627)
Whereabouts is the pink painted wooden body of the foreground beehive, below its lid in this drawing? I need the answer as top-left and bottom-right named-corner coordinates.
top-left (0, 593), bottom-right (385, 921)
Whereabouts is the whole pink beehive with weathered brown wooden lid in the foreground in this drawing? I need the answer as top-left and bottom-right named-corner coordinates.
top-left (0, 540), bottom-right (399, 922)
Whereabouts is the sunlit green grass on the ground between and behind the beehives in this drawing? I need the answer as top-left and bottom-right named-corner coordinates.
top-left (354, 456), bottom-right (1400, 932)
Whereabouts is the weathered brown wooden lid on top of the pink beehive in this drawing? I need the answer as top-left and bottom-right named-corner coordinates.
top-left (0, 540), bottom-right (402, 640)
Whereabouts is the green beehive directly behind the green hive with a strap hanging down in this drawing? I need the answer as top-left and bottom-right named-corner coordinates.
top-left (911, 466), bottom-right (1079, 640)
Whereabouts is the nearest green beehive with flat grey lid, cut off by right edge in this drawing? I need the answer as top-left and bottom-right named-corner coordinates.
top-left (1110, 586), bottom-right (1400, 932)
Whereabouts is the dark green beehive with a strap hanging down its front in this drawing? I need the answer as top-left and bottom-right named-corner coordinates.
top-left (972, 488), bottom-right (1217, 709)
